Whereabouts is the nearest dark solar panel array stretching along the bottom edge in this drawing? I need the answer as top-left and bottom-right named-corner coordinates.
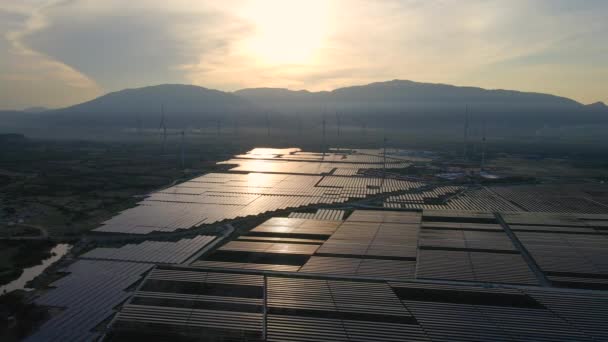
top-left (106, 267), bottom-right (608, 341)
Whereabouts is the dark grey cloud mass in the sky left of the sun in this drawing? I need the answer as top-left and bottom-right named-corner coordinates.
top-left (23, 1), bottom-right (249, 90)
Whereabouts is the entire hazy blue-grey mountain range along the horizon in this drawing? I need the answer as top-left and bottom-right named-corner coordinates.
top-left (11, 80), bottom-right (608, 131)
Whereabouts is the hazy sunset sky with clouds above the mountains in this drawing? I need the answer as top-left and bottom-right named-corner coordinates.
top-left (0, 0), bottom-right (608, 109)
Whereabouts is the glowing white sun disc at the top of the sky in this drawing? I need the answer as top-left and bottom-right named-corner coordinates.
top-left (243, 0), bottom-right (328, 65)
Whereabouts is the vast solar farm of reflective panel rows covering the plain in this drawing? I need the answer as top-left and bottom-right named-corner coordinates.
top-left (28, 148), bottom-right (608, 341)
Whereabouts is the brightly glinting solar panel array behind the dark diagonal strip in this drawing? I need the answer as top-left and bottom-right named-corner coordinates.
top-left (95, 173), bottom-right (421, 234)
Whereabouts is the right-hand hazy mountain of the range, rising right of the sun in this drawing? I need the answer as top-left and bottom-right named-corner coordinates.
top-left (235, 80), bottom-right (608, 129)
